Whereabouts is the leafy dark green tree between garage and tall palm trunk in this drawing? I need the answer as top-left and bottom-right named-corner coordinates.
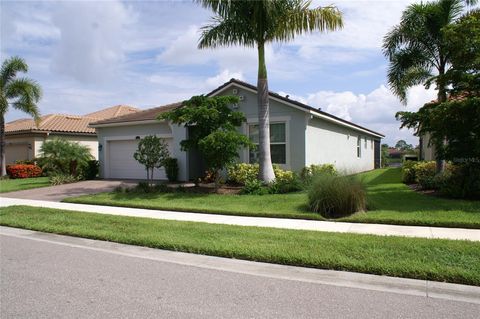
top-left (159, 95), bottom-right (252, 189)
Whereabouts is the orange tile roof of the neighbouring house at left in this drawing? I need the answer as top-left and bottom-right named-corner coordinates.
top-left (5, 105), bottom-right (138, 134)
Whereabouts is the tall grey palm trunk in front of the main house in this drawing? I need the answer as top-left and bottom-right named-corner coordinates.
top-left (257, 42), bottom-right (275, 183)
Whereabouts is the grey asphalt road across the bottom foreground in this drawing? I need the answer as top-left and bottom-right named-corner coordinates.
top-left (0, 235), bottom-right (480, 319)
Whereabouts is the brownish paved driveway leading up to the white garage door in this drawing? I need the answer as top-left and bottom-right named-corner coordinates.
top-left (1, 180), bottom-right (138, 202)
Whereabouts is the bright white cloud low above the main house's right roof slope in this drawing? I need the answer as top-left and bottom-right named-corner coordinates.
top-left (280, 85), bottom-right (436, 145)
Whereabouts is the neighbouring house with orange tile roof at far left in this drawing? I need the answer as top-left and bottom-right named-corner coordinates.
top-left (5, 105), bottom-right (138, 164)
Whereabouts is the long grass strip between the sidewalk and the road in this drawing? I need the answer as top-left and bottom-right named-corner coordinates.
top-left (0, 206), bottom-right (480, 286)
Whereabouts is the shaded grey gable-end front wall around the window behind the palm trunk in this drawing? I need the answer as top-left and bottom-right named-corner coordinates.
top-left (218, 86), bottom-right (306, 171)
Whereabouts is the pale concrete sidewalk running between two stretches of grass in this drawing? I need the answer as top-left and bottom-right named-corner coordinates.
top-left (0, 197), bottom-right (480, 241)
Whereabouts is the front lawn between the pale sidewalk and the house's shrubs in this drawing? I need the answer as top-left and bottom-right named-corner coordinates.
top-left (65, 168), bottom-right (480, 228)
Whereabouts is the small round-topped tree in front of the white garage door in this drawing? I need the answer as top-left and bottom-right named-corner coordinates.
top-left (133, 135), bottom-right (170, 185)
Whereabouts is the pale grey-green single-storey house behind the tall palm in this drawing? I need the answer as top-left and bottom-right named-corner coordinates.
top-left (90, 79), bottom-right (384, 180)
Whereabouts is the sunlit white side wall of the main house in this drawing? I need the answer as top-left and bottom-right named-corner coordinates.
top-left (305, 118), bottom-right (378, 173)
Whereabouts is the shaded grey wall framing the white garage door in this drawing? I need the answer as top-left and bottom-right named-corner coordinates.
top-left (96, 122), bottom-right (188, 180)
